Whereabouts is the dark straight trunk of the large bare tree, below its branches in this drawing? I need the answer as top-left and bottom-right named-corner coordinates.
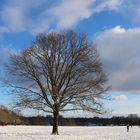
top-left (52, 111), bottom-right (59, 135)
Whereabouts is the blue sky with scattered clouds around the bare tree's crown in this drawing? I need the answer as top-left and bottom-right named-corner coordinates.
top-left (0, 0), bottom-right (140, 115)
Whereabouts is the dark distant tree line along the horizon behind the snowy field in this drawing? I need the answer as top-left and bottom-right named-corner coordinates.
top-left (0, 107), bottom-right (140, 126)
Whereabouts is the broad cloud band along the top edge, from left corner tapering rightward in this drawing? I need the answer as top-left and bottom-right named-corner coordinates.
top-left (0, 0), bottom-right (120, 34)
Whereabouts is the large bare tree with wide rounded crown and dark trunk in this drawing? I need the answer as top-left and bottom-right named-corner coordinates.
top-left (7, 31), bottom-right (108, 134)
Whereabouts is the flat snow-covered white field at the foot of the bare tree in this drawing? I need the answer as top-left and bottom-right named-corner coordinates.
top-left (0, 126), bottom-right (140, 140)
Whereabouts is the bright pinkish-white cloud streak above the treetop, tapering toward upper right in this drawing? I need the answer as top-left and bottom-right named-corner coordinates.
top-left (50, 0), bottom-right (120, 28)
